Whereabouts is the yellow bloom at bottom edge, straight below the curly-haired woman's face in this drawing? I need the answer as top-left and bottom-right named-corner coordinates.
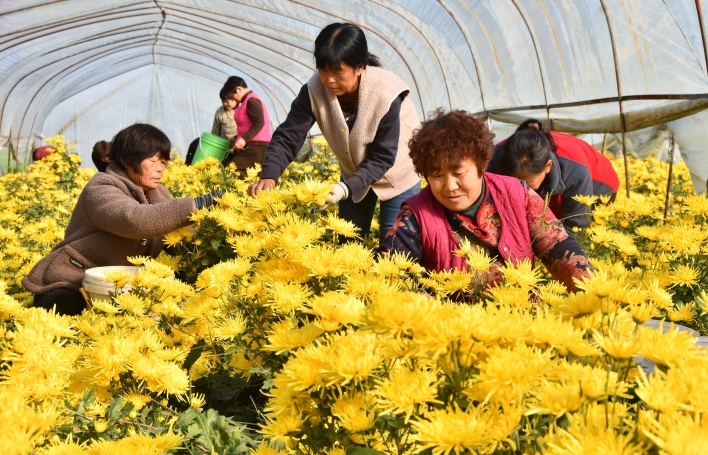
top-left (411, 406), bottom-right (498, 455)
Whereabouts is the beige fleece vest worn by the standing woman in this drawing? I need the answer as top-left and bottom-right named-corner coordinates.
top-left (307, 66), bottom-right (420, 202)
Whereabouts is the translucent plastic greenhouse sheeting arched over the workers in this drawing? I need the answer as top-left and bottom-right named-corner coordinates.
top-left (0, 0), bottom-right (708, 170)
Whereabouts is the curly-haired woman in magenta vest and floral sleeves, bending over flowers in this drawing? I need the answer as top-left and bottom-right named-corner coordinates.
top-left (380, 110), bottom-right (592, 291)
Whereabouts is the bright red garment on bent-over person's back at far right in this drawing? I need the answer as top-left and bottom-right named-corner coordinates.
top-left (551, 131), bottom-right (619, 193)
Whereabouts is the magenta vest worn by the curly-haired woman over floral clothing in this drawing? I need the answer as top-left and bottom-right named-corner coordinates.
top-left (406, 173), bottom-right (533, 272)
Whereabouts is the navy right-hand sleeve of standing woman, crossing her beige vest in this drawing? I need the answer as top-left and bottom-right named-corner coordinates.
top-left (344, 94), bottom-right (405, 196)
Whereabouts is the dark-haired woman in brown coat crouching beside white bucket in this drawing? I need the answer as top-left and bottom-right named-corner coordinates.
top-left (22, 124), bottom-right (223, 315)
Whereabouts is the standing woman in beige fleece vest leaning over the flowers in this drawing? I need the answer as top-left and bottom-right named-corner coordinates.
top-left (248, 23), bottom-right (420, 246)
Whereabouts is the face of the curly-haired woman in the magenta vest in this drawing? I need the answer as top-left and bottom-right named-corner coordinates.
top-left (427, 158), bottom-right (482, 212)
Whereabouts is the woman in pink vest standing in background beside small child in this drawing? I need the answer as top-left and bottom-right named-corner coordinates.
top-left (222, 76), bottom-right (271, 178)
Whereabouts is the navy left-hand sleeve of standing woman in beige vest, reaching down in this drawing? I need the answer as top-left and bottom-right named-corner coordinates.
top-left (261, 84), bottom-right (315, 182)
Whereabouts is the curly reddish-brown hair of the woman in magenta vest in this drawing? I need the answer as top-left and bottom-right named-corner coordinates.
top-left (408, 108), bottom-right (494, 178)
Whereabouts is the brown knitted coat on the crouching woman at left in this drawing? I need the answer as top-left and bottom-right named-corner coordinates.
top-left (22, 165), bottom-right (193, 294)
